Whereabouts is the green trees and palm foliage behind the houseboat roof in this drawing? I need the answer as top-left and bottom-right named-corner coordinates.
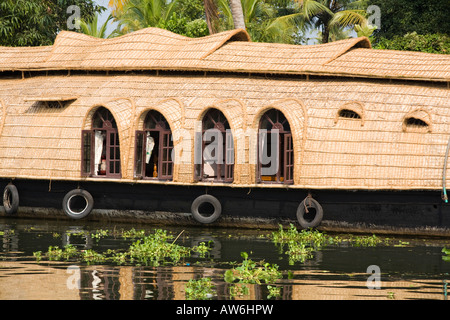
top-left (0, 0), bottom-right (450, 54)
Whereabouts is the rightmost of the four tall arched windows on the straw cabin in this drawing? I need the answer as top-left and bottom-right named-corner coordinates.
top-left (258, 109), bottom-right (294, 183)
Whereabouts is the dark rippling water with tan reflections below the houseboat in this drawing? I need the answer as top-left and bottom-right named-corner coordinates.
top-left (0, 219), bottom-right (450, 300)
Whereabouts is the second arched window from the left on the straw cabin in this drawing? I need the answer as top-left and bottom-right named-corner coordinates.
top-left (135, 110), bottom-right (173, 180)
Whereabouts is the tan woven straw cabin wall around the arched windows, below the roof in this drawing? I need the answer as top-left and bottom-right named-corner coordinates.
top-left (0, 74), bottom-right (450, 189)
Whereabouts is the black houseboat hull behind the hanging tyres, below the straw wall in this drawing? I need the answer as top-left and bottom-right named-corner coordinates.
top-left (1, 179), bottom-right (450, 235)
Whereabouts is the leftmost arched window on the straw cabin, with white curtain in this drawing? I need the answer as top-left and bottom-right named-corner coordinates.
top-left (82, 107), bottom-right (121, 178)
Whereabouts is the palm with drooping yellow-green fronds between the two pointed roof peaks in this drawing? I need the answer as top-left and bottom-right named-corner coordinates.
top-left (297, 0), bottom-right (367, 43)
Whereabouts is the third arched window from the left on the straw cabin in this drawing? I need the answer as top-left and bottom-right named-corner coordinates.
top-left (195, 109), bottom-right (234, 182)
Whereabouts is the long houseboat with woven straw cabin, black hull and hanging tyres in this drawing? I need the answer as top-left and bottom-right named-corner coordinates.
top-left (0, 28), bottom-right (450, 235)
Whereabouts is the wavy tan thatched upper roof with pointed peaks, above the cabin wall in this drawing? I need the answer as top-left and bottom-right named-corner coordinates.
top-left (0, 28), bottom-right (450, 81)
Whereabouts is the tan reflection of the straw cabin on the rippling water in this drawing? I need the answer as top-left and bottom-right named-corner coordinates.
top-left (0, 263), bottom-right (445, 300)
